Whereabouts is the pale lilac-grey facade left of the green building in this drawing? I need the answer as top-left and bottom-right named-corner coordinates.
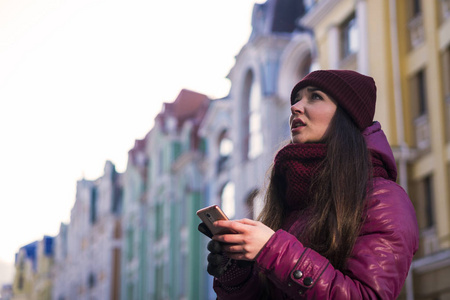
top-left (52, 161), bottom-right (122, 300)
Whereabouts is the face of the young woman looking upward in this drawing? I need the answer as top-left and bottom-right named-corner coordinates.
top-left (289, 86), bottom-right (337, 143)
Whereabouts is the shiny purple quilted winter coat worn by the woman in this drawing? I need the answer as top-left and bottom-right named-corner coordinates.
top-left (214, 122), bottom-right (419, 300)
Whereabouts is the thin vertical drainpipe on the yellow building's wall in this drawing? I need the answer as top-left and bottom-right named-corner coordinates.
top-left (389, 0), bottom-right (414, 300)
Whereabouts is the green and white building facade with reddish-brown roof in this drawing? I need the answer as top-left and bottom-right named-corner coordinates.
top-left (122, 90), bottom-right (210, 300)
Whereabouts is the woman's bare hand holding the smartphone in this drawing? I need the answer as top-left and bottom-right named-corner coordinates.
top-left (213, 219), bottom-right (275, 260)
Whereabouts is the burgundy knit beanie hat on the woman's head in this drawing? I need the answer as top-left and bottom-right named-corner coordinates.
top-left (291, 70), bottom-right (377, 130)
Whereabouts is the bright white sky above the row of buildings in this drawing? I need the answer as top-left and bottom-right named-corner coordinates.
top-left (0, 0), bottom-right (263, 278)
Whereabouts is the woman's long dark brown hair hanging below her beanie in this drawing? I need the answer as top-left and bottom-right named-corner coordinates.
top-left (258, 106), bottom-right (372, 269)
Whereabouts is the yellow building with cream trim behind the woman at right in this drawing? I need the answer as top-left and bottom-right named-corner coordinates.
top-left (300, 0), bottom-right (450, 300)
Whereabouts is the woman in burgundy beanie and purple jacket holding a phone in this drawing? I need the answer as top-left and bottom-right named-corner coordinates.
top-left (200, 70), bottom-right (419, 300)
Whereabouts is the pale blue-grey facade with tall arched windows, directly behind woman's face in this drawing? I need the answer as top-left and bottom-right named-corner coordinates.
top-left (228, 1), bottom-right (311, 218)
